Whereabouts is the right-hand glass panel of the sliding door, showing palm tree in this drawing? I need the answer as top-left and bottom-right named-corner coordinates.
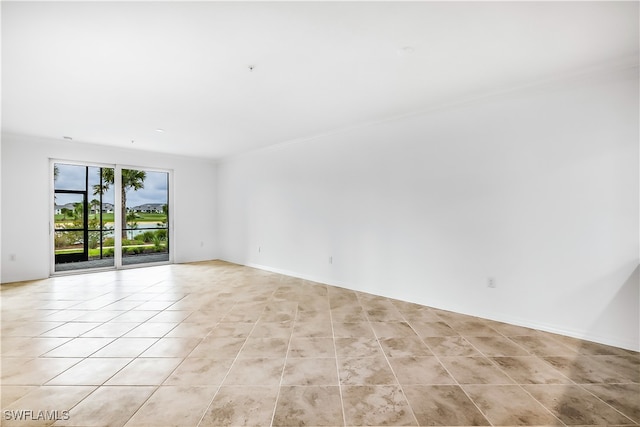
top-left (121, 169), bottom-right (169, 265)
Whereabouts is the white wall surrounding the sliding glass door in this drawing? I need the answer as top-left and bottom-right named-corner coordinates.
top-left (1, 135), bottom-right (217, 283)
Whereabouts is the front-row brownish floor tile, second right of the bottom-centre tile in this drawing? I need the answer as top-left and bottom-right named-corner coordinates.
top-left (403, 385), bottom-right (491, 426)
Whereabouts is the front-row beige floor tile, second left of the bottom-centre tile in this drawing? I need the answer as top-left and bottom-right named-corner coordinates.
top-left (125, 386), bottom-right (218, 427)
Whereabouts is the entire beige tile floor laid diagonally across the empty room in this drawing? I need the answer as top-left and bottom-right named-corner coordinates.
top-left (0, 262), bottom-right (640, 427)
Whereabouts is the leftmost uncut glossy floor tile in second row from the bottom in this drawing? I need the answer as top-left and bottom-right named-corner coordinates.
top-left (47, 357), bottom-right (132, 386)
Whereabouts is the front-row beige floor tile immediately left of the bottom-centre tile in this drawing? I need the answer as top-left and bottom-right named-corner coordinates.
top-left (200, 385), bottom-right (278, 427)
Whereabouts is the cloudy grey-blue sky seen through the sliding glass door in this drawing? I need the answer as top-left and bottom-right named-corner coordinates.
top-left (55, 163), bottom-right (169, 207)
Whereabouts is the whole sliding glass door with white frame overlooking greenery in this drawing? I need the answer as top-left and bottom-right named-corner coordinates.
top-left (52, 162), bottom-right (170, 273)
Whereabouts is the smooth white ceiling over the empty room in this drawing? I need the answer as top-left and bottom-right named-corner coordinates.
top-left (1, 1), bottom-right (639, 158)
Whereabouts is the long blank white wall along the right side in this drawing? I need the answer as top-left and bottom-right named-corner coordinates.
top-left (217, 68), bottom-right (640, 350)
